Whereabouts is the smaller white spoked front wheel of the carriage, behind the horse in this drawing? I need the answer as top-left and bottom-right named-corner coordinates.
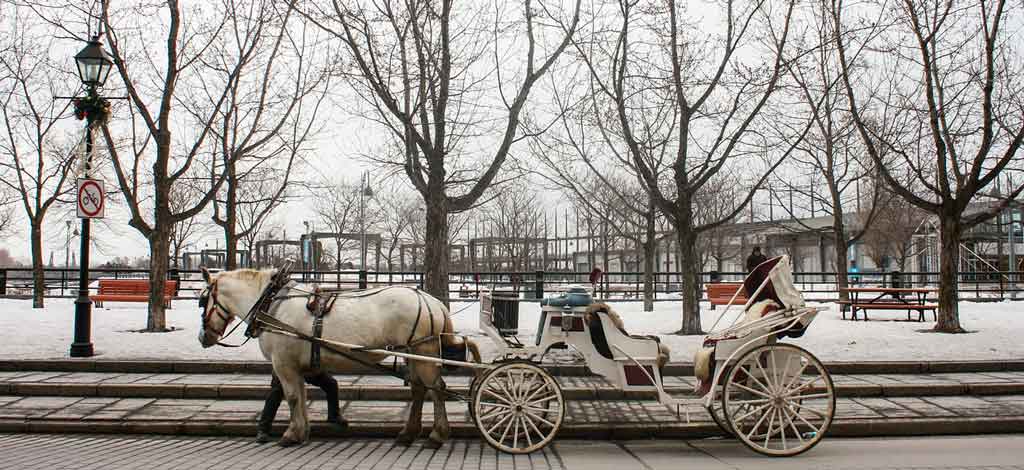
top-left (470, 362), bottom-right (565, 454)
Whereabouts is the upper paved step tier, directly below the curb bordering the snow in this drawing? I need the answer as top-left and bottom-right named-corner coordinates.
top-left (0, 371), bottom-right (1024, 400)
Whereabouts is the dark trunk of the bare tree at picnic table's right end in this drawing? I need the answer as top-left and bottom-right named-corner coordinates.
top-left (935, 211), bottom-right (964, 333)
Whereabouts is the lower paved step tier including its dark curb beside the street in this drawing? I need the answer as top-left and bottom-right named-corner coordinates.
top-left (0, 394), bottom-right (1024, 438)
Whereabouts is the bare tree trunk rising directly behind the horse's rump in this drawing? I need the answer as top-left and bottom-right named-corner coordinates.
top-left (423, 190), bottom-right (449, 305)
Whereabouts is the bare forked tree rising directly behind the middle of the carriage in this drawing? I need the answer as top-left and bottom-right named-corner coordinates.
top-left (575, 0), bottom-right (806, 334)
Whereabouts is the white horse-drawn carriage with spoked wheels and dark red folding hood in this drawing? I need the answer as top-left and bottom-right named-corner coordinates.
top-left (469, 257), bottom-right (836, 456)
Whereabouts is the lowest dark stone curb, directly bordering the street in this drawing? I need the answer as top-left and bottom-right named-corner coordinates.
top-left (0, 417), bottom-right (1024, 445)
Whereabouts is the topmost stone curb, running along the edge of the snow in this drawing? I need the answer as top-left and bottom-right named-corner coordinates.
top-left (6, 359), bottom-right (1024, 377)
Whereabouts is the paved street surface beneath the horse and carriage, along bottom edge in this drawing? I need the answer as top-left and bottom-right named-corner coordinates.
top-left (0, 434), bottom-right (1024, 470)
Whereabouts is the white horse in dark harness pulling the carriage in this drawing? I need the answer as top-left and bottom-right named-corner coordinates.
top-left (199, 269), bottom-right (480, 448)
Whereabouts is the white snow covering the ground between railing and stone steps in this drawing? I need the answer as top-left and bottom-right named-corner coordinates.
top-left (0, 299), bottom-right (1024, 362)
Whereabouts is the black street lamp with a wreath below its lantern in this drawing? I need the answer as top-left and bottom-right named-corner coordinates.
top-left (71, 35), bottom-right (114, 357)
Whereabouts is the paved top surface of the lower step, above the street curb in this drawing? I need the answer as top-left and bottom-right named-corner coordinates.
top-left (0, 395), bottom-right (1024, 426)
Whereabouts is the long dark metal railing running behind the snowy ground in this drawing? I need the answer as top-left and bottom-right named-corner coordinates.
top-left (0, 268), bottom-right (1024, 301)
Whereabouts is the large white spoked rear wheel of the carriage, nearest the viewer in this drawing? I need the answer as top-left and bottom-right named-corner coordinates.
top-left (722, 343), bottom-right (836, 457)
